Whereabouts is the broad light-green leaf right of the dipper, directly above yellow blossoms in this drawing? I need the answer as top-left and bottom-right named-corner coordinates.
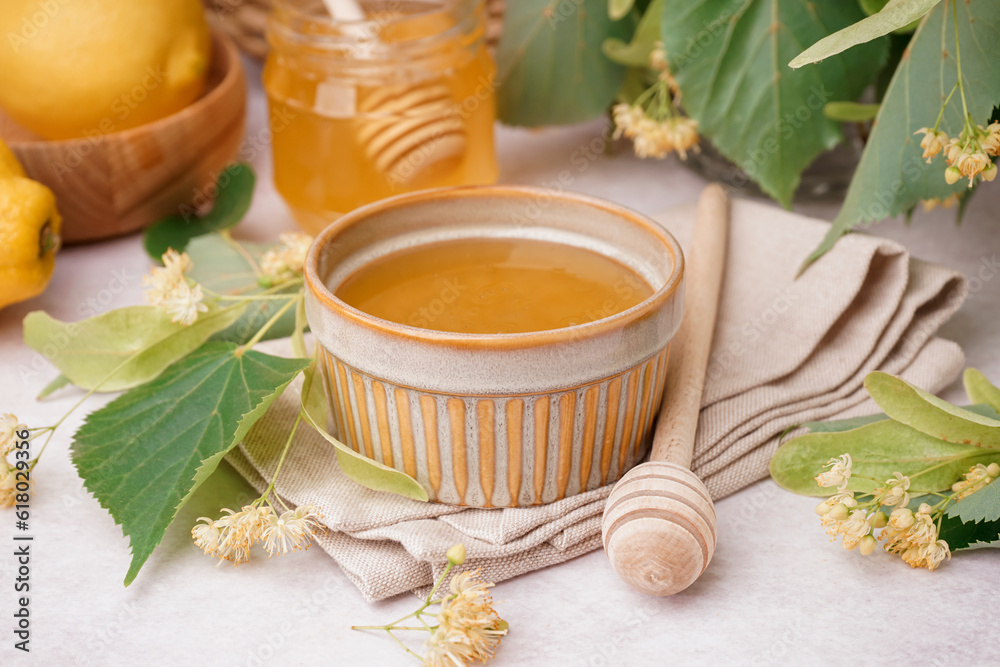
top-left (770, 420), bottom-right (1000, 496)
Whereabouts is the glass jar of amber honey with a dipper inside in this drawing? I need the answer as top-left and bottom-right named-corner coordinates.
top-left (264, 0), bottom-right (497, 234)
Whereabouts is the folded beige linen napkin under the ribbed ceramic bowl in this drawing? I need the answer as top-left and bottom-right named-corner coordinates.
top-left (227, 200), bottom-right (968, 601)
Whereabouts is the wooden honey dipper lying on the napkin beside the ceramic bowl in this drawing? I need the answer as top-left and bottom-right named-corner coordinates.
top-left (602, 184), bottom-right (729, 596)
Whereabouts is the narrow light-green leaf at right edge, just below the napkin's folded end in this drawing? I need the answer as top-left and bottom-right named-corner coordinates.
top-left (865, 371), bottom-right (1000, 450)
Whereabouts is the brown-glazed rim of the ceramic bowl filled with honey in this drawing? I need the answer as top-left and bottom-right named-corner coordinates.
top-left (304, 185), bottom-right (685, 350)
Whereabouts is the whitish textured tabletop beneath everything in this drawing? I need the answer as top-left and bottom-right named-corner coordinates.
top-left (0, 60), bottom-right (1000, 667)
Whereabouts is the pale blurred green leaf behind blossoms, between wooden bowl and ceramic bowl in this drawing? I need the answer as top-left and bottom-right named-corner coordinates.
top-left (188, 234), bottom-right (302, 343)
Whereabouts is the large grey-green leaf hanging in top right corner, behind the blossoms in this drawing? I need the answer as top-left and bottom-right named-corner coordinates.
top-left (802, 0), bottom-right (1000, 269)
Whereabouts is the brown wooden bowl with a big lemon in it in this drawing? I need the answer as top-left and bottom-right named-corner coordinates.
top-left (0, 32), bottom-right (246, 243)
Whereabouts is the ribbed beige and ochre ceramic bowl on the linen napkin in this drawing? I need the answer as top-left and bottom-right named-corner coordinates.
top-left (305, 186), bottom-right (684, 507)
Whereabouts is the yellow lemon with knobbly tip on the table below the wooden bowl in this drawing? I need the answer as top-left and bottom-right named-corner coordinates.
top-left (0, 176), bottom-right (62, 308)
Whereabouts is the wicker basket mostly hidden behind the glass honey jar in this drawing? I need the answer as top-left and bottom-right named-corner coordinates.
top-left (203, 0), bottom-right (506, 60)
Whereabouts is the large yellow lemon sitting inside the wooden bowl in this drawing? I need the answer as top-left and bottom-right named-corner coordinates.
top-left (0, 0), bottom-right (211, 139)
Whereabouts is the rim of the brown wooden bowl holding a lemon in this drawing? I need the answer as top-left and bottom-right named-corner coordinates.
top-left (5, 26), bottom-right (243, 150)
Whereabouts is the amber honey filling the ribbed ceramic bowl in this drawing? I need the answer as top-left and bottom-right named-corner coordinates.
top-left (336, 238), bottom-right (653, 334)
